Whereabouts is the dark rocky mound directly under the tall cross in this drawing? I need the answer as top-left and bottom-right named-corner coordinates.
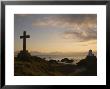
top-left (17, 50), bottom-right (31, 60)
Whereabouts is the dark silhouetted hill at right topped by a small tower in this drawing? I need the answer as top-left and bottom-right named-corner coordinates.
top-left (77, 50), bottom-right (97, 75)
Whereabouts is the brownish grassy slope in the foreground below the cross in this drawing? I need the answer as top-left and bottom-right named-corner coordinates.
top-left (14, 58), bottom-right (75, 76)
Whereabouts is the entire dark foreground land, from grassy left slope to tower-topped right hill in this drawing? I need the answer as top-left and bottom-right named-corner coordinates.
top-left (14, 50), bottom-right (97, 76)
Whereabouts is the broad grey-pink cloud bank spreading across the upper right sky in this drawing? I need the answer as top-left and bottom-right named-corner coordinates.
top-left (32, 14), bottom-right (97, 41)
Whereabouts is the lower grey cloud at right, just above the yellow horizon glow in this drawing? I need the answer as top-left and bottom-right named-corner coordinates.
top-left (63, 29), bottom-right (97, 42)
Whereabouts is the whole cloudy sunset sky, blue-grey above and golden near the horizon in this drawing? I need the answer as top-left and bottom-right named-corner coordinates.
top-left (14, 14), bottom-right (97, 53)
